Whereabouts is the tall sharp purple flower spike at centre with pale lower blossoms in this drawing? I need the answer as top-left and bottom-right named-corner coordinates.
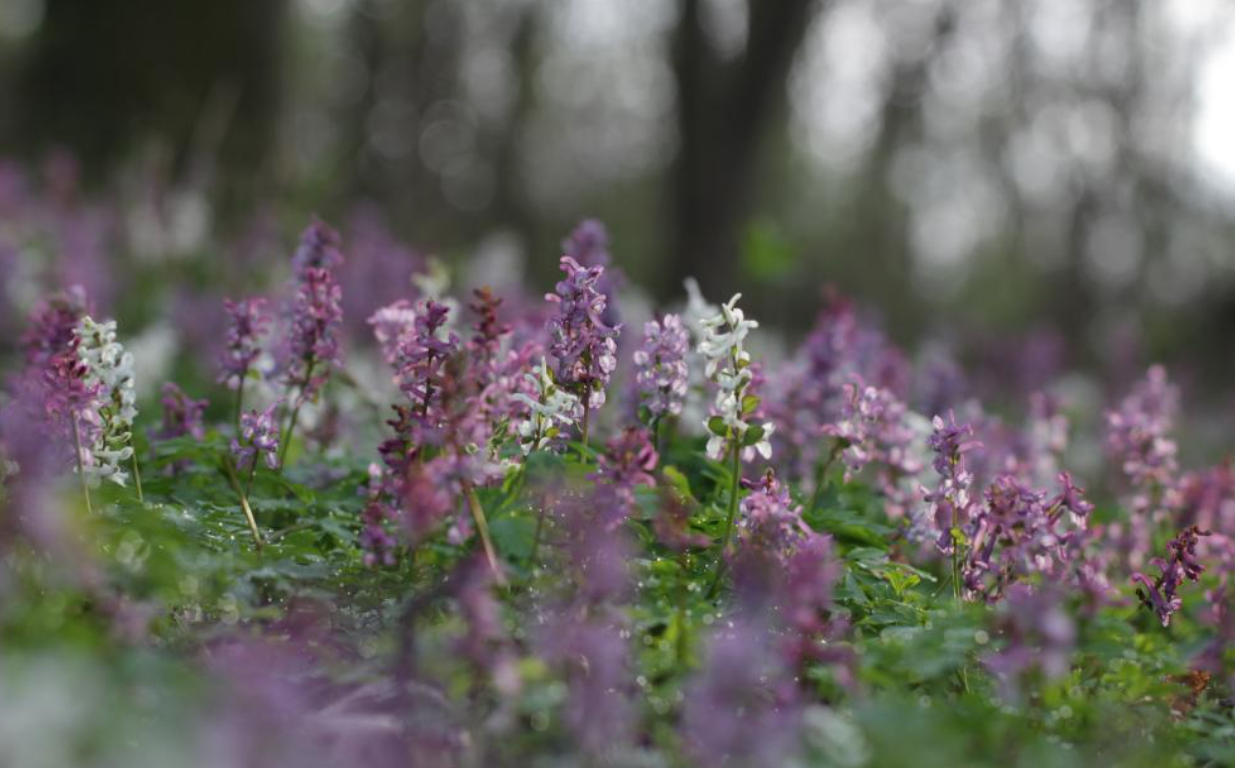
top-left (545, 256), bottom-right (621, 407)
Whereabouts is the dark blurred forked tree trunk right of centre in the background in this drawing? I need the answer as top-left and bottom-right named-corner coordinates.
top-left (666, 0), bottom-right (818, 299)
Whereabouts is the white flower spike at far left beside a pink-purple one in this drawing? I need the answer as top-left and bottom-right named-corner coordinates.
top-left (77, 315), bottom-right (137, 485)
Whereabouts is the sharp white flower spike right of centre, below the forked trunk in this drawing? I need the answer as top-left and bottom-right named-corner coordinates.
top-left (698, 294), bottom-right (772, 459)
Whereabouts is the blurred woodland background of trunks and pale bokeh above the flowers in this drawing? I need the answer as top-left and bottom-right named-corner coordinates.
top-left (0, 0), bottom-right (1235, 389)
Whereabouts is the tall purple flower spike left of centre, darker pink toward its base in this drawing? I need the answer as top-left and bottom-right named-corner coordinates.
top-left (285, 267), bottom-right (343, 400)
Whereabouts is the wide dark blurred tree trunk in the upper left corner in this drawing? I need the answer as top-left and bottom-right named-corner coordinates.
top-left (14, 0), bottom-right (287, 200)
